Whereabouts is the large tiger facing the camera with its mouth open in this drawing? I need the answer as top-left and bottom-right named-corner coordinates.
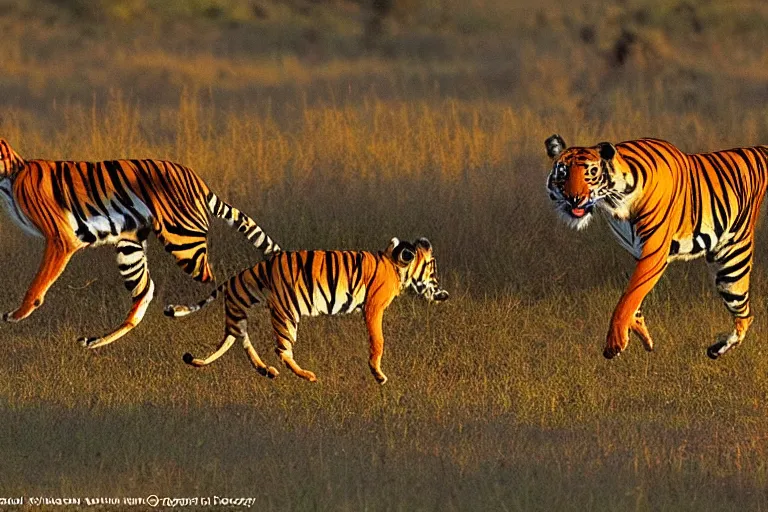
top-left (545, 135), bottom-right (768, 359)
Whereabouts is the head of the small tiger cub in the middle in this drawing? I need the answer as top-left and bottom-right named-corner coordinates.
top-left (384, 238), bottom-right (449, 302)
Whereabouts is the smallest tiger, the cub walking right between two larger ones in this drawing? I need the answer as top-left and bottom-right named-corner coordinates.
top-left (165, 238), bottom-right (449, 384)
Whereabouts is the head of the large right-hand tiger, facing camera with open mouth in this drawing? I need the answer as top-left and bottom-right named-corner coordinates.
top-left (544, 135), bottom-right (635, 229)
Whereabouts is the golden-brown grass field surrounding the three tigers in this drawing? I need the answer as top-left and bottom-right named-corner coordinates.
top-left (0, 0), bottom-right (768, 511)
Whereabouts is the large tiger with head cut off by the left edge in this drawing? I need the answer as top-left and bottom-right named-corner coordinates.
top-left (0, 139), bottom-right (280, 348)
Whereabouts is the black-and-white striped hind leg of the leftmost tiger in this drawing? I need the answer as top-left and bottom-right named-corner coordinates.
top-left (78, 238), bottom-right (155, 348)
